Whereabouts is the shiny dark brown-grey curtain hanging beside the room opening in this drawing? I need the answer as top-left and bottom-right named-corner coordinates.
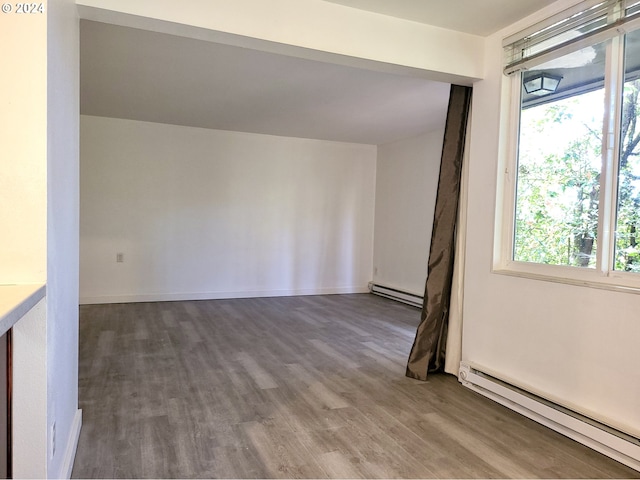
top-left (406, 85), bottom-right (472, 380)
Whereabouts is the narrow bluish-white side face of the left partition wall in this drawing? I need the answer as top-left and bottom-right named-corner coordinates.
top-left (46, 0), bottom-right (81, 478)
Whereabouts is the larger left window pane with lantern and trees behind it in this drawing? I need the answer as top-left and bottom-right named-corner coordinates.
top-left (514, 44), bottom-right (605, 268)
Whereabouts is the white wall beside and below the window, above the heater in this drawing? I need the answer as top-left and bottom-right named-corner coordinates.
top-left (463, 2), bottom-right (640, 436)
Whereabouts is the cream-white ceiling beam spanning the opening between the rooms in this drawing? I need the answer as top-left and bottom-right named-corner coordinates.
top-left (76, 0), bottom-right (484, 85)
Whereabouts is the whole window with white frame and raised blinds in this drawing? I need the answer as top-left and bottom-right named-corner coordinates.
top-left (498, 0), bottom-right (640, 287)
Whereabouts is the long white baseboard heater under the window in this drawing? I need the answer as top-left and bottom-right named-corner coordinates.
top-left (458, 362), bottom-right (640, 471)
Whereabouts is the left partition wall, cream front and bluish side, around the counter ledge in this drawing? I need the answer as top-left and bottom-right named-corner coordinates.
top-left (0, 0), bottom-right (80, 477)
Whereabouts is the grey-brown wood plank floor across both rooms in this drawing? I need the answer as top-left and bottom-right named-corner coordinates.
top-left (73, 294), bottom-right (640, 478)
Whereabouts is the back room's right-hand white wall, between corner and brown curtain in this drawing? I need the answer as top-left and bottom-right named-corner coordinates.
top-left (373, 128), bottom-right (444, 296)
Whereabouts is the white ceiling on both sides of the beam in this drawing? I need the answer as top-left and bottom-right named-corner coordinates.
top-left (80, 0), bottom-right (552, 144)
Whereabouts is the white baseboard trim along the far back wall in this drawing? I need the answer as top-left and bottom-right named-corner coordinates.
top-left (80, 285), bottom-right (369, 305)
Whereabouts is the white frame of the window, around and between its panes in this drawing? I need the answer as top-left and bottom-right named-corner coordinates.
top-left (492, 13), bottom-right (640, 294)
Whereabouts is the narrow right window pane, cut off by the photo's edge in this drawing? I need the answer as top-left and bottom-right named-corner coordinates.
top-left (614, 31), bottom-right (640, 272)
